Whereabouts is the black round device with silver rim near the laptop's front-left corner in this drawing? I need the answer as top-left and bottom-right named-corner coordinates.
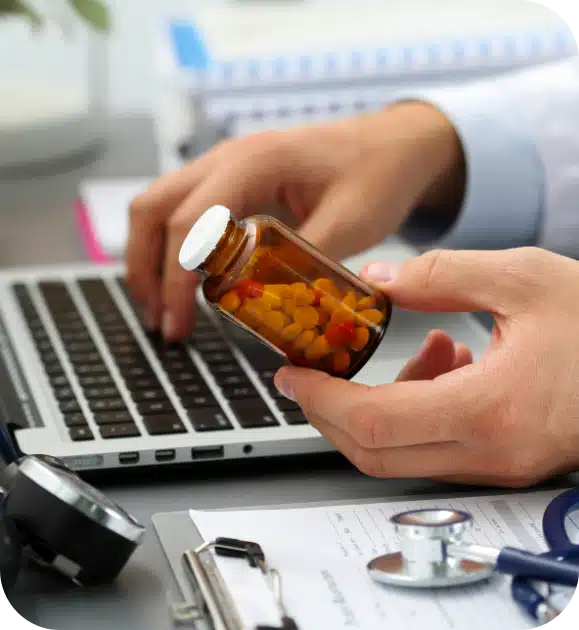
top-left (0, 421), bottom-right (145, 598)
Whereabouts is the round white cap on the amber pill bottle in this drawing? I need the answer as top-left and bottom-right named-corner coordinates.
top-left (179, 206), bottom-right (231, 271)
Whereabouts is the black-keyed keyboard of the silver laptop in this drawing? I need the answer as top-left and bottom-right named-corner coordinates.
top-left (13, 278), bottom-right (306, 441)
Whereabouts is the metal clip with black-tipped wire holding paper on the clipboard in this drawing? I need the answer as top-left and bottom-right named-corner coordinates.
top-left (172, 538), bottom-right (299, 630)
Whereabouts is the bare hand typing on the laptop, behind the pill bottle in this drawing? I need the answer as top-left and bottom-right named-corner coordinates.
top-left (126, 103), bottom-right (463, 340)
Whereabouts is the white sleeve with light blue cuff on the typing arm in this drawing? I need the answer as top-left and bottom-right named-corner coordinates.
top-left (402, 58), bottom-right (579, 258)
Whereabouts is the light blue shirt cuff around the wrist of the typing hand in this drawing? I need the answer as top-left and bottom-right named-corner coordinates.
top-left (396, 85), bottom-right (544, 249)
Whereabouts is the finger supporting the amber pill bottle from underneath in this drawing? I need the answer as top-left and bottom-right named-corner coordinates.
top-left (275, 367), bottom-right (484, 449)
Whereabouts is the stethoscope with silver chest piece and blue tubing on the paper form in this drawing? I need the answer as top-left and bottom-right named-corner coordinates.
top-left (367, 488), bottom-right (579, 622)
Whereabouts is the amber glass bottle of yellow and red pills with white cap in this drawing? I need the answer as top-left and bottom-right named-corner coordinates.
top-left (179, 206), bottom-right (392, 379)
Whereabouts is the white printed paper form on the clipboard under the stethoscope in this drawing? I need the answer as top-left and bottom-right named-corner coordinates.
top-left (191, 491), bottom-right (579, 630)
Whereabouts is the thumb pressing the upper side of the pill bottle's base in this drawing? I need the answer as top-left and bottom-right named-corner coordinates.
top-left (360, 248), bottom-right (545, 315)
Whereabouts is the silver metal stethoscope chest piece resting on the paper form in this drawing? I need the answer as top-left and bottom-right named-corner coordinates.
top-left (367, 509), bottom-right (495, 588)
